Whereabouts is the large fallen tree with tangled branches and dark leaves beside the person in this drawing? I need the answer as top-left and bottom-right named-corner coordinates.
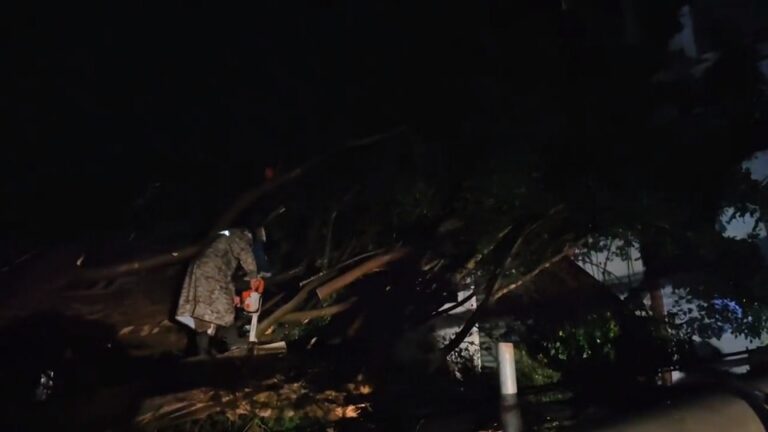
top-left (57, 0), bottom-right (764, 390)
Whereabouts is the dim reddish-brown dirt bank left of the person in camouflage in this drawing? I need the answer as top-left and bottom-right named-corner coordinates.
top-left (0, 247), bottom-right (186, 355)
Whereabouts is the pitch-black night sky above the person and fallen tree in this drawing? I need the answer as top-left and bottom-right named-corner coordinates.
top-left (6, 0), bottom-right (768, 250)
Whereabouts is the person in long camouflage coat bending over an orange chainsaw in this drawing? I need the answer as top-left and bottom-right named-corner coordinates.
top-left (176, 229), bottom-right (258, 355)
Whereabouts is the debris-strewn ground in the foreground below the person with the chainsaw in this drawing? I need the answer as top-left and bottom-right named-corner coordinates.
top-left (0, 251), bottom-right (510, 431)
